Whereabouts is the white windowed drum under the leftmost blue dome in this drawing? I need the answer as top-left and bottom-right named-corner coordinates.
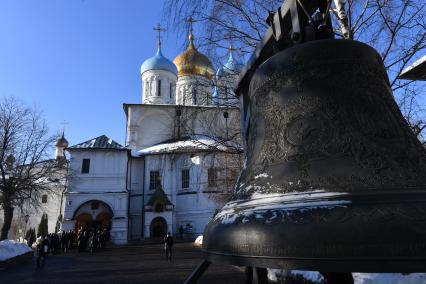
top-left (142, 70), bottom-right (177, 104)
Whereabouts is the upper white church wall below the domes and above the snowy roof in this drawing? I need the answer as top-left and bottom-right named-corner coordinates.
top-left (126, 104), bottom-right (241, 149)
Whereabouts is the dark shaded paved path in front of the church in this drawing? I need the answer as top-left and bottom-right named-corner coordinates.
top-left (0, 243), bottom-right (244, 284)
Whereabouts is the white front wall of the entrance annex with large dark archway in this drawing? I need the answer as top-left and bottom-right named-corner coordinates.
top-left (61, 149), bottom-right (129, 244)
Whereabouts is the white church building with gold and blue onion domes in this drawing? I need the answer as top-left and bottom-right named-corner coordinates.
top-left (61, 23), bottom-right (242, 244)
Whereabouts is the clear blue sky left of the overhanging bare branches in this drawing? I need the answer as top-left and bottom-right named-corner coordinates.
top-left (0, 0), bottom-right (182, 149)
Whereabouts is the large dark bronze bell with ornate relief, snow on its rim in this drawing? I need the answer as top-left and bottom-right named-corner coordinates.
top-left (203, 39), bottom-right (426, 272)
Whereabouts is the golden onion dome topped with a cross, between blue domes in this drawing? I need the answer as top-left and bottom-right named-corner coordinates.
top-left (173, 31), bottom-right (214, 79)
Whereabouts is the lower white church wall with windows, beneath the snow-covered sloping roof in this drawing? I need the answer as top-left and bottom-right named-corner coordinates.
top-left (139, 152), bottom-right (240, 237)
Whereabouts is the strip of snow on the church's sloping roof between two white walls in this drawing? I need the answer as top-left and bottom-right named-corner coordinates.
top-left (132, 135), bottom-right (242, 157)
